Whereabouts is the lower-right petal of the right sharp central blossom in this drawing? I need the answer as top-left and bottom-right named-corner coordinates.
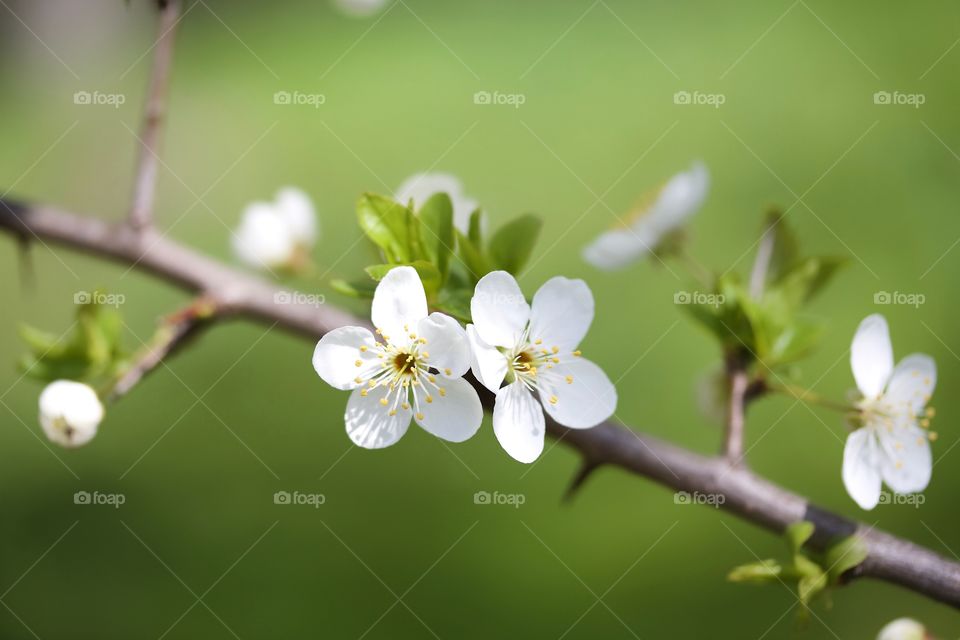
top-left (537, 358), bottom-right (617, 429)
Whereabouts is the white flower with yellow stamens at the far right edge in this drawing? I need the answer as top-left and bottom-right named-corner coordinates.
top-left (843, 314), bottom-right (937, 509)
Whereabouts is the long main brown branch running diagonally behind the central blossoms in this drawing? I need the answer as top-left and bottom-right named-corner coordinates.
top-left (0, 199), bottom-right (960, 608)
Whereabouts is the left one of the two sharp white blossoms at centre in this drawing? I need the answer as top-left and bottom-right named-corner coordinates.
top-left (313, 267), bottom-right (483, 449)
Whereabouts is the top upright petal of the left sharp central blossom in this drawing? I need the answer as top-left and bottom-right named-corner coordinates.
top-left (371, 267), bottom-right (427, 347)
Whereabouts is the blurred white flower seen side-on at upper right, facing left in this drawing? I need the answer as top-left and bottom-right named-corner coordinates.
top-left (583, 162), bottom-right (710, 271)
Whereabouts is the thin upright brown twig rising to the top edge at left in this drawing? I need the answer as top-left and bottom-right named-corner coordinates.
top-left (130, 0), bottom-right (180, 230)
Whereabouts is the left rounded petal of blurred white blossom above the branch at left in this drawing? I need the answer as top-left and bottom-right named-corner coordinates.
top-left (233, 202), bottom-right (296, 269)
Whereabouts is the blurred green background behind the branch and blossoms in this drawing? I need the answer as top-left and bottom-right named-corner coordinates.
top-left (0, 0), bottom-right (960, 639)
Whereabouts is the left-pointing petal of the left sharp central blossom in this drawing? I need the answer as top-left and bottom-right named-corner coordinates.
top-left (313, 327), bottom-right (381, 390)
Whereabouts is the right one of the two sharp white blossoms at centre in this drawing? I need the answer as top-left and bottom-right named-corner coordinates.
top-left (467, 271), bottom-right (617, 462)
